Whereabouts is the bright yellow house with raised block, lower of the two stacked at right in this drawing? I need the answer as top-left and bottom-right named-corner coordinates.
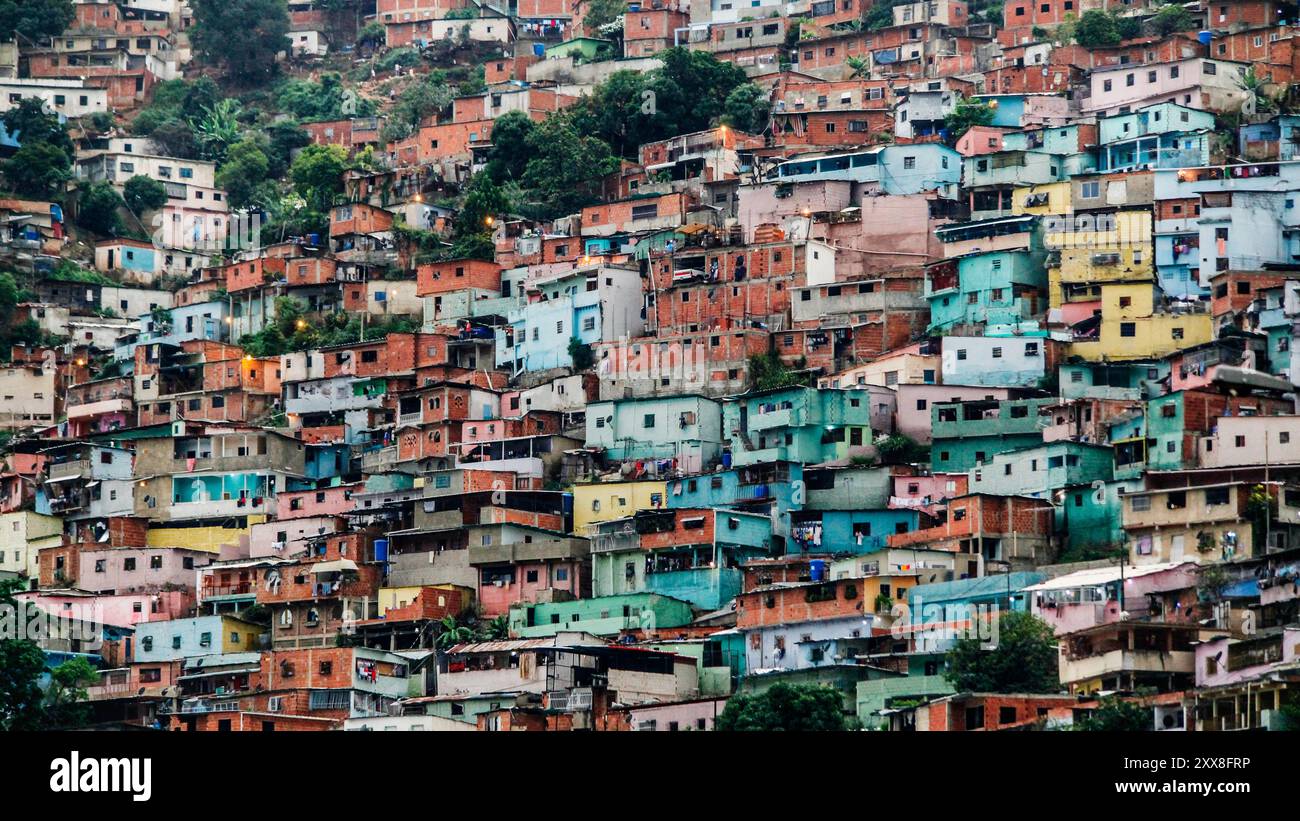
top-left (1070, 282), bottom-right (1214, 362)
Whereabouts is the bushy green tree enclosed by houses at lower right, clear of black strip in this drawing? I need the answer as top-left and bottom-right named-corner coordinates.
top-left (944, 611), bottom-right (1061, 692)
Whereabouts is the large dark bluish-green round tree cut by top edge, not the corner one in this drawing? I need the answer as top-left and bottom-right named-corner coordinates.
top-left (190, 0), bottom-right (290, 83)
